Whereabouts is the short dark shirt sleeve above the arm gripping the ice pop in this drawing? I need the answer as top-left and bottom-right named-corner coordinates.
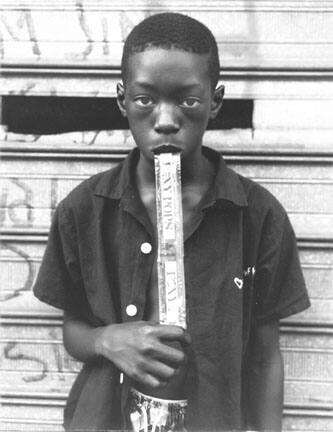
top-left (33, 203), bottom-right (89, 315)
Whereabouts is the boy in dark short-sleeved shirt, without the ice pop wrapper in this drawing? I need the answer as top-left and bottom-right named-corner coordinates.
top-left (34, 13), bottom-right (309, 430)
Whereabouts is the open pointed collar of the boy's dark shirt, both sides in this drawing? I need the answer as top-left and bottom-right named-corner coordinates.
top-left (93, 147), bottom-right (247, 207)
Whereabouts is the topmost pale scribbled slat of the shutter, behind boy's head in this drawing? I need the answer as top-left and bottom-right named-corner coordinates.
top-left (0, 6), bottom-right (333, 68)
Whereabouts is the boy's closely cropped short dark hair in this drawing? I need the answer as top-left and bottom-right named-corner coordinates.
top-left (121, 12), bottom-right (220, 89)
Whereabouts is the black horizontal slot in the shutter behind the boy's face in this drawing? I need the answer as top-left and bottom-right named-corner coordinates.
top-left (2, 96), bottom-right (253, 135)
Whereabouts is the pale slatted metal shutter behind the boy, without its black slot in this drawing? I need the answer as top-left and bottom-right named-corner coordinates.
top-left (0, 0), bottom-right (333, 431)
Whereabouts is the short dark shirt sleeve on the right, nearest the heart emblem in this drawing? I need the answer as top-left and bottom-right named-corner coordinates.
top-left (255, 205), bottom-right (310, 323)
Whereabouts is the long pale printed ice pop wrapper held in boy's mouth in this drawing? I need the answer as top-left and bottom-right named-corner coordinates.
top-left (154, 153), bottom-right (186, 328)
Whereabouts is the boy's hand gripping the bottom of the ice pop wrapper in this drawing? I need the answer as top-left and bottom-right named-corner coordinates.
top-left (96, 321), bottom-right (190, 388)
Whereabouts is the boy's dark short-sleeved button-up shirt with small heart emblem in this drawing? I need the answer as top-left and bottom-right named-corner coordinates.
top-left (34, 148), bottom-right (309, 430)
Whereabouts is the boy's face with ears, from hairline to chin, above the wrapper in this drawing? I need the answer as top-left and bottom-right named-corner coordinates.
top-left (118, 48), bottom-right (223, 163)
